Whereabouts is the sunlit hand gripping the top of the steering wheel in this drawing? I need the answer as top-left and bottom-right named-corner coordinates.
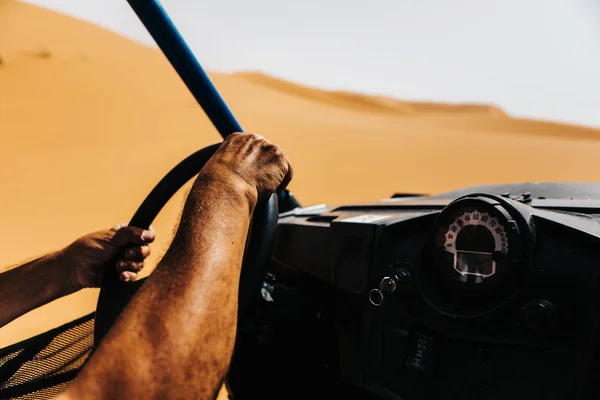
top-left (197, 133), bottom-right (293, 203)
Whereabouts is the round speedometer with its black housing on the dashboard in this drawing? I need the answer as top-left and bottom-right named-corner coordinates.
top-left (417, 194), bottom-right (530, 316)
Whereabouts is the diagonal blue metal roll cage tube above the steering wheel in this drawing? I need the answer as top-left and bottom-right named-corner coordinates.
top-left (127, 0), bottom-right (243, 138)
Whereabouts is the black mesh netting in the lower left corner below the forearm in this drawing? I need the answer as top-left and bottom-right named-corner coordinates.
top-left (0, 313), bottom-right (94, 400)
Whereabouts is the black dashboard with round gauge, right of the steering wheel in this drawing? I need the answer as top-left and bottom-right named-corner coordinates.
top-left (227, 183), bottom-right (600, 400)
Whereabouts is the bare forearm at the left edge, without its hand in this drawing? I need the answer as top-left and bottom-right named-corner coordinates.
top-left (0, 251), bottom-right (79, 327)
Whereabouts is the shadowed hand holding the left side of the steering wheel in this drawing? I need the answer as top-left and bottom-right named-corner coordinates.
top-left (60, 224), bottom-right (154, 289)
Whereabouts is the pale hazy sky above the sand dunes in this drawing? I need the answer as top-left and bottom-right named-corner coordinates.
top-left (21, 0), bottom-right (600, 127)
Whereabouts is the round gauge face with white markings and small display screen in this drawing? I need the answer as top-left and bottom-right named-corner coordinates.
top-left (442, 210), bottom-right (508, 278)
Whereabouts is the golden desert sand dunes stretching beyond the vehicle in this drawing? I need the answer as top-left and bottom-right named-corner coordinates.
top-left (0, 0), bottom-right (600, 356)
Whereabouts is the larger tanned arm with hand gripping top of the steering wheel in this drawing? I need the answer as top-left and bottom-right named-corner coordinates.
top-left (64, 134), bottom-right (291, 399)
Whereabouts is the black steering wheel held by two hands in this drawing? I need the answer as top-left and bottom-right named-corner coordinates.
top-left (94, 143), bottom-right (278, 347)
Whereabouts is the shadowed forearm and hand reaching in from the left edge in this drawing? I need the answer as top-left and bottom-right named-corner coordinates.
top-left (0, 224), bottom-right (154, 328)
